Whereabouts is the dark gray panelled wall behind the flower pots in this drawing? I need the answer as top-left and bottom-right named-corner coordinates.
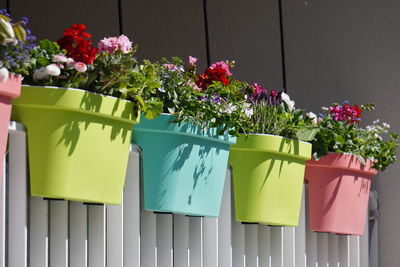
top-left (5, 0), bottom-right (400, 267)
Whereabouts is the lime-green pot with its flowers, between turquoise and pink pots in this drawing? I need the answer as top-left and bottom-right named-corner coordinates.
top-left (229, 84), bottom-right (313, 226)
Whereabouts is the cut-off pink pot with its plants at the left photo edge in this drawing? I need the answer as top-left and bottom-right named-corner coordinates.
top-left (0, 10), bottom-right (35, 184)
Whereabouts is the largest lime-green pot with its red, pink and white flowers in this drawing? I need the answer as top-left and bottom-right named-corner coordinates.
top-left (12, 24), bottom-right (158, 204)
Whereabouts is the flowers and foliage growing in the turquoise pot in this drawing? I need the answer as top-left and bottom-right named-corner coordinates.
top-left (148, 57), bottom-right (249, 136)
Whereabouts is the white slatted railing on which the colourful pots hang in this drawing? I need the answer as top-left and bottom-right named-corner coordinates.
top-left (0, 123), bottom-right (368, 267)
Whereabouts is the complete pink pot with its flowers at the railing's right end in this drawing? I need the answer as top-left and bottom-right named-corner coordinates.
top-left (305, 102), bottom-right (399, 235)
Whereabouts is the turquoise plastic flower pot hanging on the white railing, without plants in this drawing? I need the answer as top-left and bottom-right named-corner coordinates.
top-left (133, 114), bottom-right (236, 217)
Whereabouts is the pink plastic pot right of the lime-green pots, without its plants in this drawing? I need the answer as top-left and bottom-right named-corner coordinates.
top-left (305, 153), bottom-right (376, 235)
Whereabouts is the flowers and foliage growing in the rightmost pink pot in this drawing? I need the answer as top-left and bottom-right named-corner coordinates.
top-left (312, 103), bottom-right (399, 170)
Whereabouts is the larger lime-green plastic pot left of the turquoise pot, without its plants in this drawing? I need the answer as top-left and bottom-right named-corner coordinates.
top-left (12, 86), bottom-right (139, 204)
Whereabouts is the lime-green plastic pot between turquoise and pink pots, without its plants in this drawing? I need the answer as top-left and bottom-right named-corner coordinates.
top-left (229, 134), bottom-right (311, 226)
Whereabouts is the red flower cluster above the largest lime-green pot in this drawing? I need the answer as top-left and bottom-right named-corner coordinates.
top-left (57, 24), bottom-right (97, 64)
